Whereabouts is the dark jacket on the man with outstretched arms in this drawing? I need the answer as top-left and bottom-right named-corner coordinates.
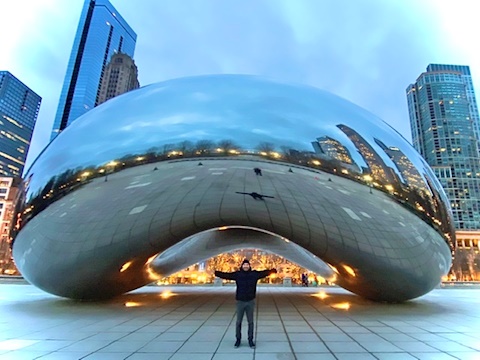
top-left (215, 269), bottom-right (276, 301)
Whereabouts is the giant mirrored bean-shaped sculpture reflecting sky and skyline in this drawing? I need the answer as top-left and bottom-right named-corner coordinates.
top-left (12, 75), bottom-right (454, 301)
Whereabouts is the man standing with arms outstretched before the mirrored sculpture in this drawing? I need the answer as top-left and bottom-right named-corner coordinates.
top-left (215, 259), bottom-right (277, 348)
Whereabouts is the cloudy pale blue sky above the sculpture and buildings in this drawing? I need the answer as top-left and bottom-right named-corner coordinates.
top-left (0, 0), bottom-right (480, 166)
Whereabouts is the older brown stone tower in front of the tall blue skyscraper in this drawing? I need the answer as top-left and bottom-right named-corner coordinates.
top-left (98, 53), bottom-right (140, 105)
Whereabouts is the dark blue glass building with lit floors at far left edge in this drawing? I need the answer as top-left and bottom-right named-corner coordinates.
top-left (0, 71), bottom-right (42, 177)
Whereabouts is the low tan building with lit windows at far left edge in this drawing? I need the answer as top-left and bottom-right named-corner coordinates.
top-left (0, 177), bottom-right (21, 275)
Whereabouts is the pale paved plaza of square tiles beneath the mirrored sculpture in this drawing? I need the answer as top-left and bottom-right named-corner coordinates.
top-left (0, 283), bottom-right (480, 360)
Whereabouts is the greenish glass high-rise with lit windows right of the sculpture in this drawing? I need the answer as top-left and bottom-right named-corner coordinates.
top-left (406, 64), bottom-right (480, 230)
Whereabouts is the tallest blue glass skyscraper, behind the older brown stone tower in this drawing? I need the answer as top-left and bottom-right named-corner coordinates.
top-left (51, 0), bottom-right (137, 139)
